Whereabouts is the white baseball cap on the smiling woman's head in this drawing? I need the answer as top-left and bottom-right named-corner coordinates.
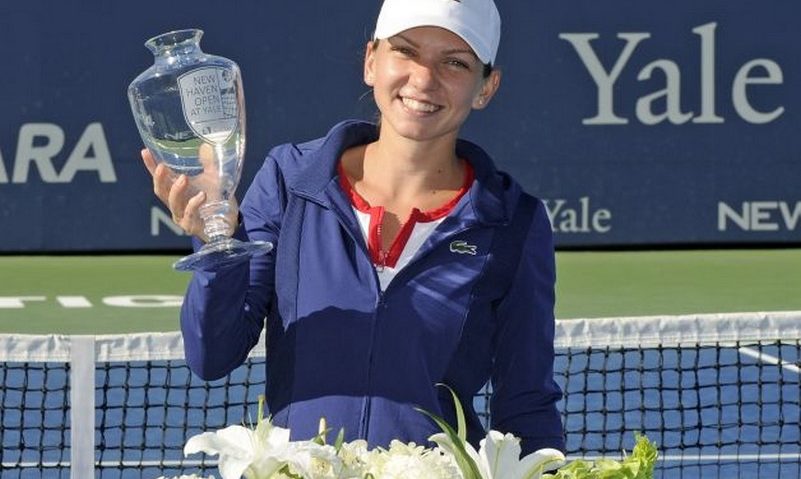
top-left (373, 0), bottom-right (501, 64)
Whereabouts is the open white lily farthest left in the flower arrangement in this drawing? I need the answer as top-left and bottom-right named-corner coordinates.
top-left (184, 420), bottom-right (292, 479)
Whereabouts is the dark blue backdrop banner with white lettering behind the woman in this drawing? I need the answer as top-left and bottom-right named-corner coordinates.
top-left (0, 0), bottom-right (801, 252)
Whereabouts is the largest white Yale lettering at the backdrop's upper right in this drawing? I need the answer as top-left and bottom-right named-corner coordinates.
top-left (559, 22), bottom-right (784, 125)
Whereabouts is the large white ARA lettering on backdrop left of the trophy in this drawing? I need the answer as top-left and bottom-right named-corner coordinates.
top-left (0, 123), bottom-right (117, 183)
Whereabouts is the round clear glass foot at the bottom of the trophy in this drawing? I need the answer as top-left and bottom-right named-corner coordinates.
top-left (172, 238), bottom-right (273, 271)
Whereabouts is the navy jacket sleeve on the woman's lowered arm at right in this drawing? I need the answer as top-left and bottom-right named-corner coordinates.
top-left (490, 202), bottom-right (565, 454)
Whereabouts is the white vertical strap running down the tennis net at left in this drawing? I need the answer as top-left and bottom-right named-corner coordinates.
top-left (70, 336), bottom-right (95, 479)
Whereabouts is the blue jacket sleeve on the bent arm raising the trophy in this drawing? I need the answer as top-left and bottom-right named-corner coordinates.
top-left (181, 156), bottom-right (286, 380)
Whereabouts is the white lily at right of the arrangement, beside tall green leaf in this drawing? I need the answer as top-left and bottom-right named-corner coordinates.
top-left (429, 431), bottom-right (565, 479)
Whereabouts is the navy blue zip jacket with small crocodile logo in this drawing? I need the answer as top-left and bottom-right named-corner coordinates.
top-left (181, 121), bottom-right (564, 453)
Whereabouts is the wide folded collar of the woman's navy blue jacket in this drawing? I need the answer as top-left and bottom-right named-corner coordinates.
top-left (290, 120), bottom-right (520, 224)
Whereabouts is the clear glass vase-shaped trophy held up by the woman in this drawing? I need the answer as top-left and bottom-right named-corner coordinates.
top-left (128, 30), bottom-right (272, 271)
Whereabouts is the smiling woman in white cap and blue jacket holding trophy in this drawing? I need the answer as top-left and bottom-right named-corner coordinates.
top-left (143, 0), bottom-right (564, 453)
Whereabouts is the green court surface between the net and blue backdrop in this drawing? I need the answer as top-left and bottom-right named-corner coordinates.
top-left (0, 249), bottom-right (801, 334)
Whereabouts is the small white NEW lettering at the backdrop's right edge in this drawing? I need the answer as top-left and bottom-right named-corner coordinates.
top-left (718, 201), bottom-right (801, 231)
